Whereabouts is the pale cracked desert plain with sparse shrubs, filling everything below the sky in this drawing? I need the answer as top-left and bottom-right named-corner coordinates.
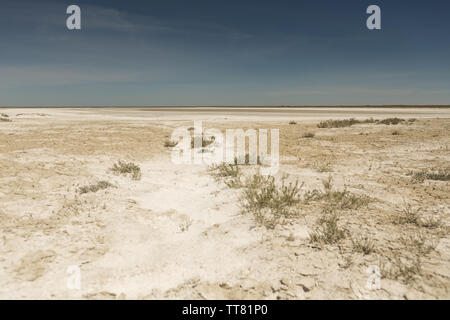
top-left (0, 107), bottom-right (450, 299)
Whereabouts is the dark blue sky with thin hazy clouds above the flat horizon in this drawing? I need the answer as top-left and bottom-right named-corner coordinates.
top-left (0, 0), bottom-right (450, 106)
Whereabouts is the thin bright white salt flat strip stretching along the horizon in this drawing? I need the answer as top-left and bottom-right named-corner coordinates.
top-left (0, 107), bottom-right (450, 121)
